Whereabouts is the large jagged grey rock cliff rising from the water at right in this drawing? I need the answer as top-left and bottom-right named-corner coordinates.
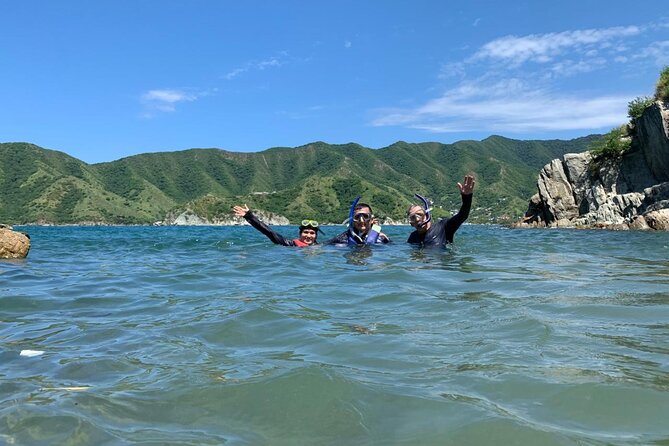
top-left (513, 102), bottom-right (669, 230)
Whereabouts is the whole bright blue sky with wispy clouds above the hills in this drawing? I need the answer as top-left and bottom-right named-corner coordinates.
top-left (0, 0), bottom-right (669, 163)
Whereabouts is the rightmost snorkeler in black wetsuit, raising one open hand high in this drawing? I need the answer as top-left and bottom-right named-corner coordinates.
top-left (407, 175), bottom-right (476, 246)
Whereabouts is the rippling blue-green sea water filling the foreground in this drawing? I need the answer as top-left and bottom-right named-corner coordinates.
top-left (0, 225), bottom-right (669, 445)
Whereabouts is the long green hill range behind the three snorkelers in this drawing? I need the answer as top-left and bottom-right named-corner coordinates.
top-left (0, 136), bottom-right (597, 224)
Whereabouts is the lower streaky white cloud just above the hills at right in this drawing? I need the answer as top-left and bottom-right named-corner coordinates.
top-left (372, 79), bottom-right (631, 133)
